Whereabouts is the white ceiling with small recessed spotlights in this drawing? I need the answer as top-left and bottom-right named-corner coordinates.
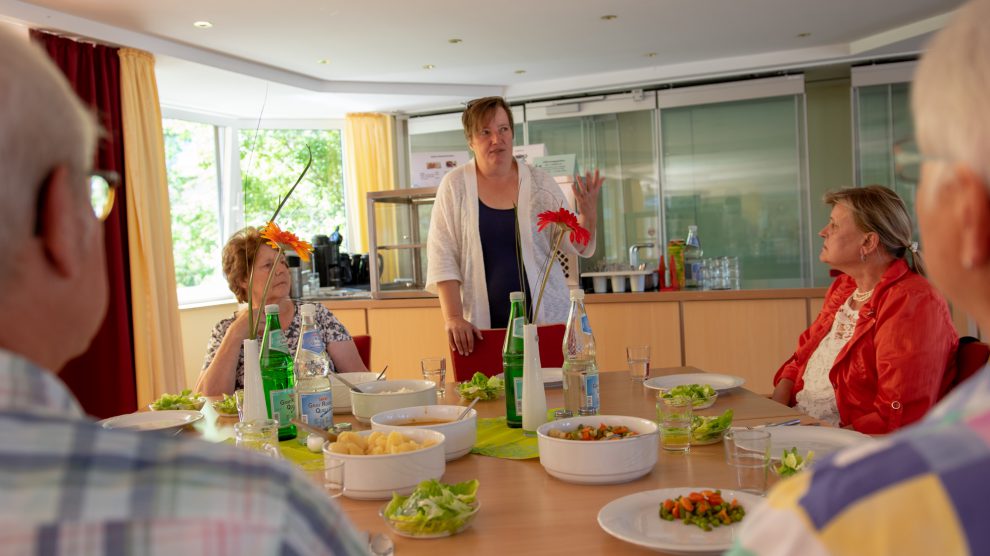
top-left (0, 0), bottom-right (962, 119)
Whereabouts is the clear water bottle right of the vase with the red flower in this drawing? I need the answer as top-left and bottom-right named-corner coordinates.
top-left (563, 289), bottom-right (600, 415)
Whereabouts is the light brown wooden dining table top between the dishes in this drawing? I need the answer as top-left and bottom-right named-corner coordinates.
top-left (196, 367), bottom-right (819, 556)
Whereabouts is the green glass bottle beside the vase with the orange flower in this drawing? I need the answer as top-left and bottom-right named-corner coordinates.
top-left (260, 305), bottom-right (296, 440)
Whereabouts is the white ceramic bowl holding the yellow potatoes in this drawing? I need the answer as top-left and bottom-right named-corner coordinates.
top-left (323, 428), bottom-right (447, 500)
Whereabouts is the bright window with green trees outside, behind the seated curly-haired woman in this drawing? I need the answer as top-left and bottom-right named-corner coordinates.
top-left (163, 118), bottom-right (348, 305)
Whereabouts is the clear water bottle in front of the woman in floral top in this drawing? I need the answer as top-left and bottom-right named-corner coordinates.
top-left (294, 303), bottom-right (333, 444)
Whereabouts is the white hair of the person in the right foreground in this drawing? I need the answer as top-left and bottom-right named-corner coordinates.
top-left (912, 0), bottom-right (990, 184)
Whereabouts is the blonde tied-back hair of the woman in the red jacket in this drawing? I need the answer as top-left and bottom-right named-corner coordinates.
top-left (822, 185), bottom-right (925, 276)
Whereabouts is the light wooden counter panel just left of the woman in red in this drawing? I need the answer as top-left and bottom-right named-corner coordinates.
top-left (684, 299), bottom-right (807, 393)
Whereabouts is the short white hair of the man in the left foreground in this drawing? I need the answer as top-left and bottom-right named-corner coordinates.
top-left (0, 29), bottom-right (99, 264)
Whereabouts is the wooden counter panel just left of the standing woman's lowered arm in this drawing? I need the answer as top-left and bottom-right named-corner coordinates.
top-left (368, 307), bottom-right (454, 382)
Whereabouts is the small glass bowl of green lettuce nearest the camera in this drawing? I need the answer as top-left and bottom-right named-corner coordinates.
top-left (379, 479), bottom-right (481, 539)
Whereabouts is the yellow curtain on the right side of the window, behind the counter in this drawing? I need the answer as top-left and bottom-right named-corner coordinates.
top-left (344, 114), bottom-right (395, 252)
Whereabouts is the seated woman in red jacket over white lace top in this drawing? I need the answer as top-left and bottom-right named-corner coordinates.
top-left (773, 185), bottom-right (958, 434)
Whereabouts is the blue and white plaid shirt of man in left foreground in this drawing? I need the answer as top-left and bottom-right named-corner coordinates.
top-left (0, 350), bottom-right (367, 556)
